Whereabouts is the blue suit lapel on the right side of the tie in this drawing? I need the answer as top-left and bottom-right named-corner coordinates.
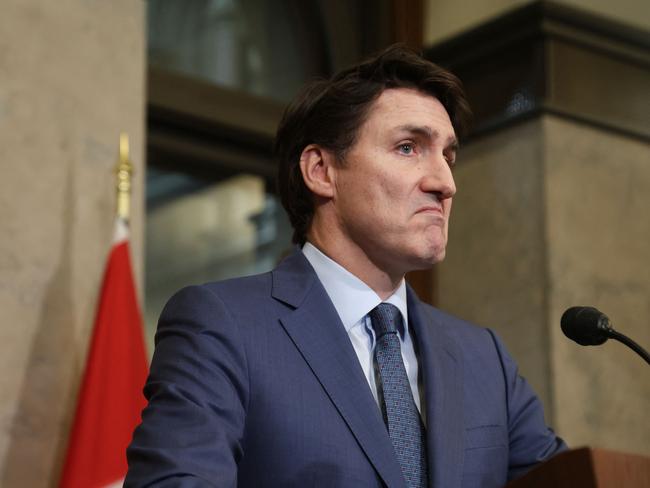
top-left (408, 289), bottom-right (465, 488)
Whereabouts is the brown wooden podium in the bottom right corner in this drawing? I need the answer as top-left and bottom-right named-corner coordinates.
top-left (506, 447), bottom-right (650, 488)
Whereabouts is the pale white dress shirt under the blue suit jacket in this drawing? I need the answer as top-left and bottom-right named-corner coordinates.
top-left (302, 242), bottom-right (422, 412)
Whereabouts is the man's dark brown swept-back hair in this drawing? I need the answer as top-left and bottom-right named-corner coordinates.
top-left (274, 45), bottom-right (470, 245)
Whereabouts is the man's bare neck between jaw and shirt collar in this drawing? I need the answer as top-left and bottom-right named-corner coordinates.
top-left (307, 218), bottom-right (404, 300)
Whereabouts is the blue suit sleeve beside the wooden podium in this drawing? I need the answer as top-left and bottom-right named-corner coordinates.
top-left (489, 330), bottom-right (567, 480)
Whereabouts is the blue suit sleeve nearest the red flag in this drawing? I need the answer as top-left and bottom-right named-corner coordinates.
top-left (124, 286), bottom-right (248, 488)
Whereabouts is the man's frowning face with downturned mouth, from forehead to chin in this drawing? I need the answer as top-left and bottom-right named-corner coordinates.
top-left (332, 88), bottom-right (457, 274)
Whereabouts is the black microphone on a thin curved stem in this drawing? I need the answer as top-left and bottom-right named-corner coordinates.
top-left (560, 307), bottom-right (650, 364)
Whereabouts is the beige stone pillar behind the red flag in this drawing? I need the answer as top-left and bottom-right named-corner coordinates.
top-left (0, 0), bottom-right (145, 488)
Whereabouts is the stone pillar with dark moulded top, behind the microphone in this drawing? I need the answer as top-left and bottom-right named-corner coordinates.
top-left (428, 3), bottom-right (650, 455)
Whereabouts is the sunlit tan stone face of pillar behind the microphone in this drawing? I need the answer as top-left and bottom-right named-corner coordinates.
top-left (544, 117), bottom-right (650, 455)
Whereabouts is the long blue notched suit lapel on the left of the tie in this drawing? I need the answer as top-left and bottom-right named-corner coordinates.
top-left (273, 251), bottom-right (405, 488)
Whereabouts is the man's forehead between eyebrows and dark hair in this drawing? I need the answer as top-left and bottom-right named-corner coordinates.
top-left (362, 88), bottom-right (455, 138)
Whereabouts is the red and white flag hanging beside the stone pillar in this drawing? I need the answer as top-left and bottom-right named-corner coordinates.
top-left (60, 218), bottom-right (148, 488)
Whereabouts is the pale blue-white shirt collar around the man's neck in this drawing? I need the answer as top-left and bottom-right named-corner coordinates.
top-left (302, 242), bottom-right (408, 338)
